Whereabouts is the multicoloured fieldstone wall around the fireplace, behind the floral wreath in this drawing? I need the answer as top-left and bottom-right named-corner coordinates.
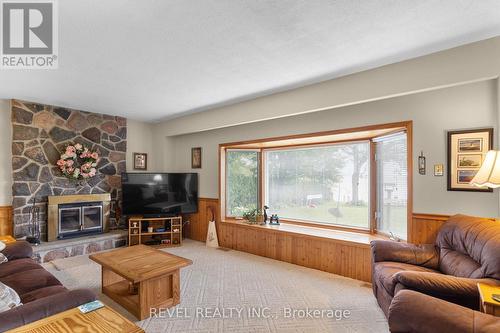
top-left (12, 100), bottom-right (127, 240)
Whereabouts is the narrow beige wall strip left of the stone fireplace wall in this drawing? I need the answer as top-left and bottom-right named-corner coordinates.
top-left (0, 99), bottom-right (12, 206)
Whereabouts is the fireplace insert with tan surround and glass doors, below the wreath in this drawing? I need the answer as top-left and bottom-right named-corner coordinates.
top-left (47, 193), bottom-right (111, 242)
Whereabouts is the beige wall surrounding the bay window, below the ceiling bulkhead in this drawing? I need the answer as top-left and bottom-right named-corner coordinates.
top-left (165, 80), bottom-right (499, 216)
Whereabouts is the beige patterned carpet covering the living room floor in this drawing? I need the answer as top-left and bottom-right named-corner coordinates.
top-left (45, 240), bottom-right (388, 333)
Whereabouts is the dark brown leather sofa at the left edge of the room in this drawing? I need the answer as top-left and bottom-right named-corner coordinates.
top-left (0, 241), bottom-right (96, 332)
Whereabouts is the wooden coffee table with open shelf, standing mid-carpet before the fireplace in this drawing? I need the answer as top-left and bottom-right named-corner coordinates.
top-left (90, 245), bottom-right (193, 320)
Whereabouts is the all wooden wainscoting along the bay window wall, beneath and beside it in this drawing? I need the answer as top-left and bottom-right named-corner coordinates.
top-left (184, 198), bottom-right (458, 282)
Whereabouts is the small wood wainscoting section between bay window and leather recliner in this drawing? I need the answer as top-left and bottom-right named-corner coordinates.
top-left (409, 213), bottom-right (450, 244)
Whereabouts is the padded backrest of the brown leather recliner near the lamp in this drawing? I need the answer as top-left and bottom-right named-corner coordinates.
top-left (436, 215), bottom-right (500, 279)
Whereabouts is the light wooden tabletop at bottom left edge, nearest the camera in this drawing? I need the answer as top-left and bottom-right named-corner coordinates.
top-left (7, 306), bottom-right (144, 333)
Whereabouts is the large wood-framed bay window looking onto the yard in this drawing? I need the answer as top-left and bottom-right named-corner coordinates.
top-left (220, 122), bottom-right (411, 239)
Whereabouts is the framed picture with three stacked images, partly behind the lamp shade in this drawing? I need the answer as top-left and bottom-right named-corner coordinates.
top-left (448, 128), bottom-right (493, 192)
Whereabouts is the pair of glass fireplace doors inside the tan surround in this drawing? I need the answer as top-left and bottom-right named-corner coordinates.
top-left (57, 202), bottom-right (103, 239)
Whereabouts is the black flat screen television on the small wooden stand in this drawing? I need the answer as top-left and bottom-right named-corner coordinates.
top-left (122, 173), bottom-right (198, 217)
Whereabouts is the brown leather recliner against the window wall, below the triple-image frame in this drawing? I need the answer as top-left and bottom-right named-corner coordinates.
top-left (371, 215), bottom-right (500, 316)
